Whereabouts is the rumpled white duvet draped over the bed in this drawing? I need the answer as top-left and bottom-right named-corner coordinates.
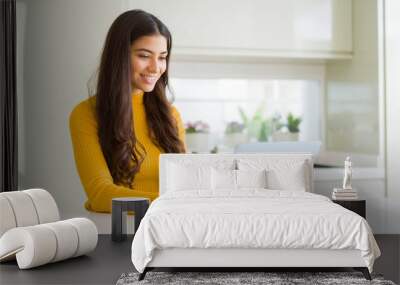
top-left (132, 189), bottom-right (380, 272)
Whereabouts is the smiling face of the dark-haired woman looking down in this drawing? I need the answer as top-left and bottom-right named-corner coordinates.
top-left (131, 35), bottom-right (168, 93)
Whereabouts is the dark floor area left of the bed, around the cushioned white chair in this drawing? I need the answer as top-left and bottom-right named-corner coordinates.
top-left (0, 235), bottom-right (134, 285)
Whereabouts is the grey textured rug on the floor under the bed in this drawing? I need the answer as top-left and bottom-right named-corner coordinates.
top-left (117, 271), bottom-right (395, 285)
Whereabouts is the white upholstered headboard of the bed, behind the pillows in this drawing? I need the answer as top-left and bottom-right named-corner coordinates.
top-left (159, 153), bottom-right (314, 195)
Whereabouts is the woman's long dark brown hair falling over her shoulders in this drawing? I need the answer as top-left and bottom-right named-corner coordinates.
top-left (96, 10), bottom-right (185, 187)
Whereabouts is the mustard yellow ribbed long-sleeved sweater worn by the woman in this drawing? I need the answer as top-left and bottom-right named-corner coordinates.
top-left (70, 93), bottom-right (185, 212)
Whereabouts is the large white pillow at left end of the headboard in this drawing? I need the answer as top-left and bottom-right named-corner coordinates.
top-left (167, 163), bottom-right (211, 191)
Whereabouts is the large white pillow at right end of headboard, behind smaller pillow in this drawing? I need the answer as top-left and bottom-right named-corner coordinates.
top-left (237, 158), bottom-right (311, 191)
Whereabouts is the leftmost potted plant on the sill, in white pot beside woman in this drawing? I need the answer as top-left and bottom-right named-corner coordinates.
top-left (185, 121), bottom-right (210, 153)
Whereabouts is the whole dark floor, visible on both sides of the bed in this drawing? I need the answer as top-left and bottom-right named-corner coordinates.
top-left (0, 235), bottom-right (400, 285)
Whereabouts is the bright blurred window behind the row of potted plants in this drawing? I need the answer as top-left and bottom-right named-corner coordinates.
top-left (171, 78), bottom-right (321, 151)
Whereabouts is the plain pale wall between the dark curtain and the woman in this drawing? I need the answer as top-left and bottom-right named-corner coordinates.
top-left (17, 0), bottom-right (121, 217)
